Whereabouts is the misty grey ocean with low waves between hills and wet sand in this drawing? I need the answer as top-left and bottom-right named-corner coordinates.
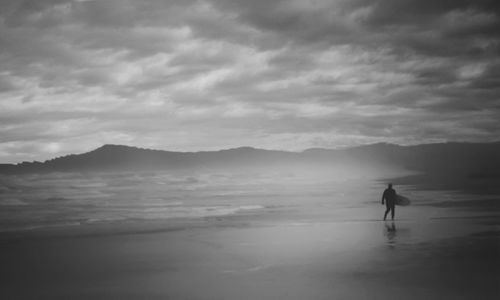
top-left (0, 172), bottom-right (500, 236)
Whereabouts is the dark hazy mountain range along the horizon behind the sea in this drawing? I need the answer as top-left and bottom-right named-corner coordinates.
top-left (0, 142), bottom-right (500, 178)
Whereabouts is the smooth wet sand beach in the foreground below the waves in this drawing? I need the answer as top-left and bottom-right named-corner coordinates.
top-left (0, 211), bottom-right (500, 299)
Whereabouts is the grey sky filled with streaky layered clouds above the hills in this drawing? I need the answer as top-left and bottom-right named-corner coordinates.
top-left (0, 0), bottom-right (500, 163)
